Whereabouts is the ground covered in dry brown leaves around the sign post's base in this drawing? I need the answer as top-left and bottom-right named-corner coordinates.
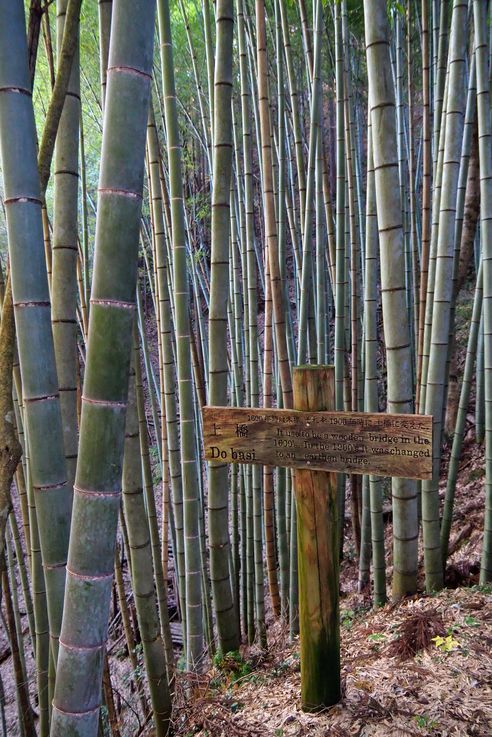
top-left (176, 587), bottom-right (492, 737)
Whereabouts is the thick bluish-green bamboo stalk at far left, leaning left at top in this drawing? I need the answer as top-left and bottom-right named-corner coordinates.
top-left (0, 0), bottom-right (72, 660)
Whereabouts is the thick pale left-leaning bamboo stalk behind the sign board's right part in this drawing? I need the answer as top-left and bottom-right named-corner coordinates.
top-left (364, 0), bottom-right (418, 599)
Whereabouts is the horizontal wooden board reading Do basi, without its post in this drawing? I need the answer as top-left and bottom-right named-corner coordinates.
top-left (203, 407), bottom-right (432, 479)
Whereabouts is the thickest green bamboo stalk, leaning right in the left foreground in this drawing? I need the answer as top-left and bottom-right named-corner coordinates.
top-left (50, 0), bottom-right (160, 737)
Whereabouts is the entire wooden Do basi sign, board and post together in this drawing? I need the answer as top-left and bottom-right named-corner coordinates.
top-left (203, 366), bottom-right (432, 711)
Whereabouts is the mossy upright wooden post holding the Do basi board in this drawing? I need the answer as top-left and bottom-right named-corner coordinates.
top-left (293, 366), bottom-right (340, 711)
